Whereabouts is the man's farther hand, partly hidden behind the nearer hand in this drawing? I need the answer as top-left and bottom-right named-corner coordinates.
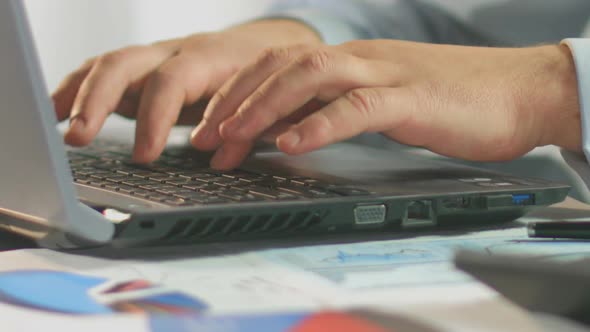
top-left (53, 20), bottom-right (321, 163)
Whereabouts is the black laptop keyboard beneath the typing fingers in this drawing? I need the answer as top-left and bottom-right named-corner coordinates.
top-left (68, 142), bottom-right (369, 206)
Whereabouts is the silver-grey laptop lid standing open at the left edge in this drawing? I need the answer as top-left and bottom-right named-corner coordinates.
top-left (0, 0), bottom-right (114, 245)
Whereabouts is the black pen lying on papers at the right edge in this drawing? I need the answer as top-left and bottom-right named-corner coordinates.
top-left (528, 221), bottom-right (590, 240)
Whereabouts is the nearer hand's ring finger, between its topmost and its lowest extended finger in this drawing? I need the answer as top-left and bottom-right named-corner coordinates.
top-left (221, 50), bottom-right (400, 141)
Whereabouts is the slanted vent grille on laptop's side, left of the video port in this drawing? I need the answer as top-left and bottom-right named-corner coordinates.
top-left (165, 211), bottom-right (326, 240)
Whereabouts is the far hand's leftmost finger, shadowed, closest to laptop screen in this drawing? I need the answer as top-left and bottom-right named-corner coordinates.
top-left (51, 58), bottom-right (96, 121)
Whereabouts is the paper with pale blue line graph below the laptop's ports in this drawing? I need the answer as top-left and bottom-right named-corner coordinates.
top-left (262, 229), bottom-right (590, 289)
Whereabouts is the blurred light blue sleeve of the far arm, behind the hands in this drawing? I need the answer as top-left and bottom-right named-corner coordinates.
top-left (267, 0), bottom-right (494, 45)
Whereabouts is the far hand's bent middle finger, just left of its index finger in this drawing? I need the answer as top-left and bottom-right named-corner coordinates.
top-left (65, 47), bottom-right (177, 146)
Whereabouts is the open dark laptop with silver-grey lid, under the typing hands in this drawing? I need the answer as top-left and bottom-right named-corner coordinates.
top-left (0, 0), bottom-right (569, 248)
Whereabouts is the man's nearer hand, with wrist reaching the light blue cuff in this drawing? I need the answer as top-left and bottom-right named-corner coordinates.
top-left (197, 40), bottom-right (581, 169)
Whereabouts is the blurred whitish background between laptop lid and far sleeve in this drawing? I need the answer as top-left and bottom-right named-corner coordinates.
top-left (25, 0), bottom-right (271, 91)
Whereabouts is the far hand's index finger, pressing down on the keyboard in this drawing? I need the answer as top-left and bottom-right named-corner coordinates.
top-left (133, 56), bottom-right (215, 163)
